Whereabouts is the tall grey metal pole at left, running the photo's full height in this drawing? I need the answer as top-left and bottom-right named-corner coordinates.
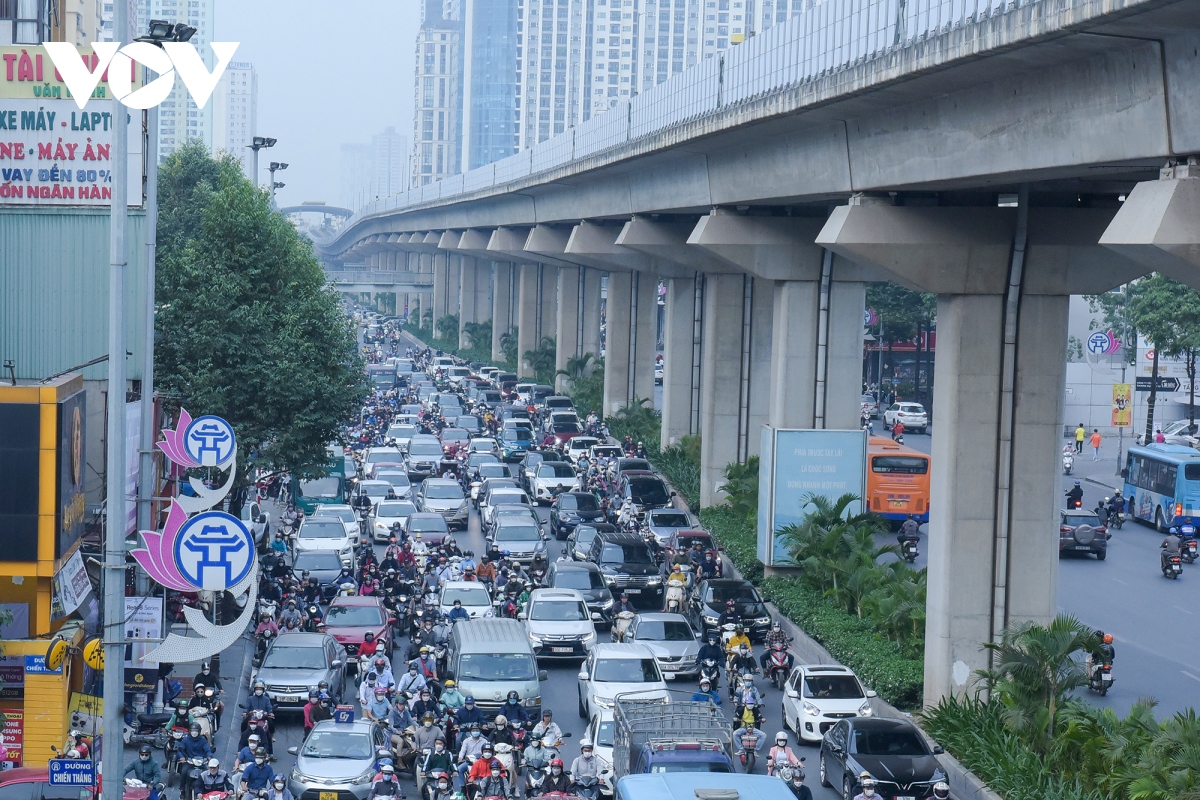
top-left (101, 2), bottom-right (130, 798)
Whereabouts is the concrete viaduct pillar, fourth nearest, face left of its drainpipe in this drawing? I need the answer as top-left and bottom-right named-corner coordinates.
top-left (661, 277), bottom-right (703, 446)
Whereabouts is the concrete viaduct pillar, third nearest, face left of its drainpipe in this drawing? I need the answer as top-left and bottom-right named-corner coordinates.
top-left (700, 273), bottom-right (751, 509)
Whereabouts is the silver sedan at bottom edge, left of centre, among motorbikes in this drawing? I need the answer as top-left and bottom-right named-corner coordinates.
top-left (288, 718), bottom-right (390, 800)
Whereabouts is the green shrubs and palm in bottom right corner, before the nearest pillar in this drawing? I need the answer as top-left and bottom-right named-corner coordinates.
top-left (922, 615), bottom-right (1200, 800)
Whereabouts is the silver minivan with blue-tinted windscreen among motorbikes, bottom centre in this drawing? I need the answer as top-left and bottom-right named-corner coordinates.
top-left (444, 619), bottom-right (548, 720)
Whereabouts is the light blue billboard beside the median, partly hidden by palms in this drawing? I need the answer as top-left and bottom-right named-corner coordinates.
top-left (757, 426), bottom-right (866, 566)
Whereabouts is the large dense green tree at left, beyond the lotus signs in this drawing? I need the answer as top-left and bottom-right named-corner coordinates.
top-left (155, 144), bottom-right (367, 496)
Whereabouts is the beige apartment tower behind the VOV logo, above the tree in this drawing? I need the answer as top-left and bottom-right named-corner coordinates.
top-left (134, 0), bottom-right (216, 161)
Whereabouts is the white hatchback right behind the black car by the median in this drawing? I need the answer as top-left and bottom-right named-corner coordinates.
top-left (784, 664), bottom-right (875, 742)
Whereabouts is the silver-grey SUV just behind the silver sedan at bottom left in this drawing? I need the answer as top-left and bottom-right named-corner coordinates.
top-left (253, 633), bottom-right (346, 709)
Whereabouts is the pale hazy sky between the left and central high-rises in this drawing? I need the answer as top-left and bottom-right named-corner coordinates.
top-left (214, 0), bottom-right (420, 205)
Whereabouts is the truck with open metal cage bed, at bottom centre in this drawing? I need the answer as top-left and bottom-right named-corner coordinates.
top-left (612, 696), bottom-right (733, 780)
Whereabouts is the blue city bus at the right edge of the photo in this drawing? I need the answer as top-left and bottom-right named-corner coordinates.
top-left (1121, 444), bottom-right (1200, 531)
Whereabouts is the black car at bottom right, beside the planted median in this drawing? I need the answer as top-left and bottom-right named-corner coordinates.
top-left (821, 717), bottom-right (946, 800)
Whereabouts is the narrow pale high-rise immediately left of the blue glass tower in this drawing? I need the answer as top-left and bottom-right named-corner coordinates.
top-left (410, 0), bottom-right (463, 187)
